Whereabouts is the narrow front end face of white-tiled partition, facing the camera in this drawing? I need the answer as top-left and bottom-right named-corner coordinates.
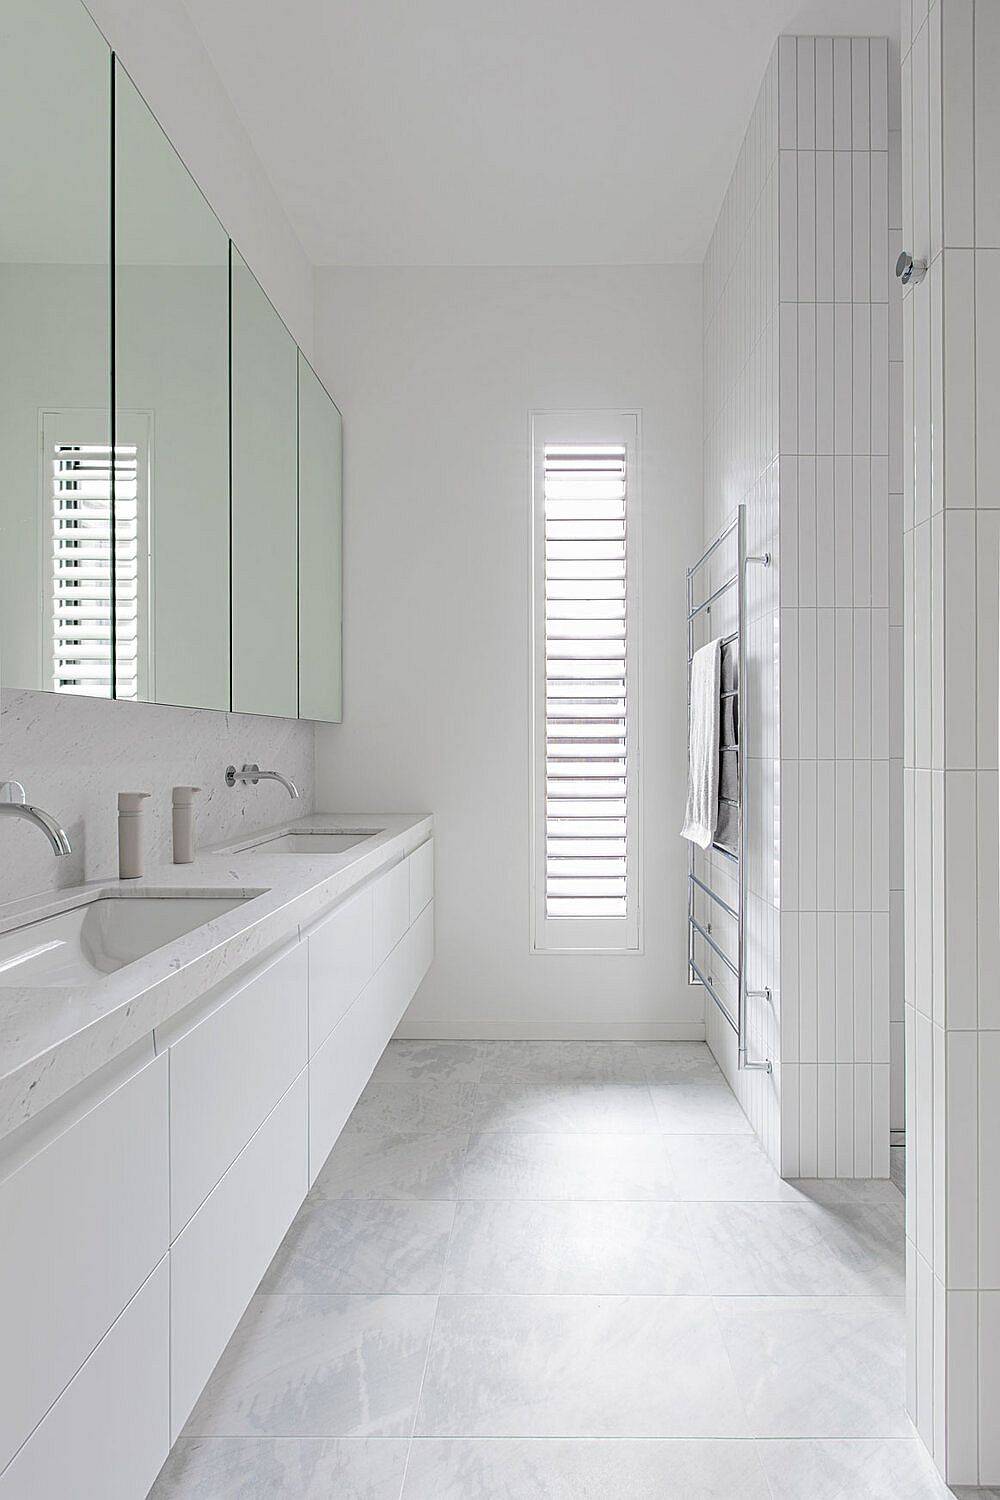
top-left (778, 36), bottom-right (903, 1178)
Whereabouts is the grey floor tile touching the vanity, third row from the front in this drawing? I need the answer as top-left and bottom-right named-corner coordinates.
top-left (259, 1202), bottom-right (454, 1292)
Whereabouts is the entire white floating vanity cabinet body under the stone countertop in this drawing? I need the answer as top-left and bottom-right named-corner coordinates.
top-left (0, 840), bottom-right (433, 1500)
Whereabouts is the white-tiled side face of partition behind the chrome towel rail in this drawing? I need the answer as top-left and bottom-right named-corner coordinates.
top-left (688, 38), bottom-right (781, 1163)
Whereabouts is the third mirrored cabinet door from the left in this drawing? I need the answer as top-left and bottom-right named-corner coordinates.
top-left (231, 246), bottom-right (298, 719)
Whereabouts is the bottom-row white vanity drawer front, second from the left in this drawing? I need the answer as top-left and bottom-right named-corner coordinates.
top-left (169, 1070), bottom-right (309, 1440)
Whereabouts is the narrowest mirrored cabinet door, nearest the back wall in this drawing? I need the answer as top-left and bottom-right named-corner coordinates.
top-left (298, 353), bottom-right (343, 723)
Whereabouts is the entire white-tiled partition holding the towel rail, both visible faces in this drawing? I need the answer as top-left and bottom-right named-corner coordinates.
top-left (696, 36), bottom-right (903, 1176)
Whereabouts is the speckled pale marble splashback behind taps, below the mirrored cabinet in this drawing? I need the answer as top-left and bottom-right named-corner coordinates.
top-left (0, 690), bottom-right (315, 902)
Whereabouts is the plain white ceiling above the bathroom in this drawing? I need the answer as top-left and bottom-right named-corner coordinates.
top-left (186, 0), bottom-right (900, 266)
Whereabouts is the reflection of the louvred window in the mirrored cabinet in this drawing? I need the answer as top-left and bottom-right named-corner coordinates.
top-left (45, 417), bottom-right (148, 699)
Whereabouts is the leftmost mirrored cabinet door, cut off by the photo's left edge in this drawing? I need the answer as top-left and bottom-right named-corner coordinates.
top-left (0, 0), bottom-right (111, 698)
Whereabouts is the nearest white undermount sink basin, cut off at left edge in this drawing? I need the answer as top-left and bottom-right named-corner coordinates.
top-left (0, 896), bottom-right (250, 986)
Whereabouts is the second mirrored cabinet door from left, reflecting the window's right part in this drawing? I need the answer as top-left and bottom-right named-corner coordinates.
top-left (114, 62), bottom-right (229, 708)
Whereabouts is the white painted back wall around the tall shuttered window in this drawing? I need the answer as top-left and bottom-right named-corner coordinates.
top-left (316, 267), bottom-right (702, 1037)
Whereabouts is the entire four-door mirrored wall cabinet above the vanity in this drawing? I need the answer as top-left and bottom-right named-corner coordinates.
top-left (0, 0), bottom-right (342, 722)
